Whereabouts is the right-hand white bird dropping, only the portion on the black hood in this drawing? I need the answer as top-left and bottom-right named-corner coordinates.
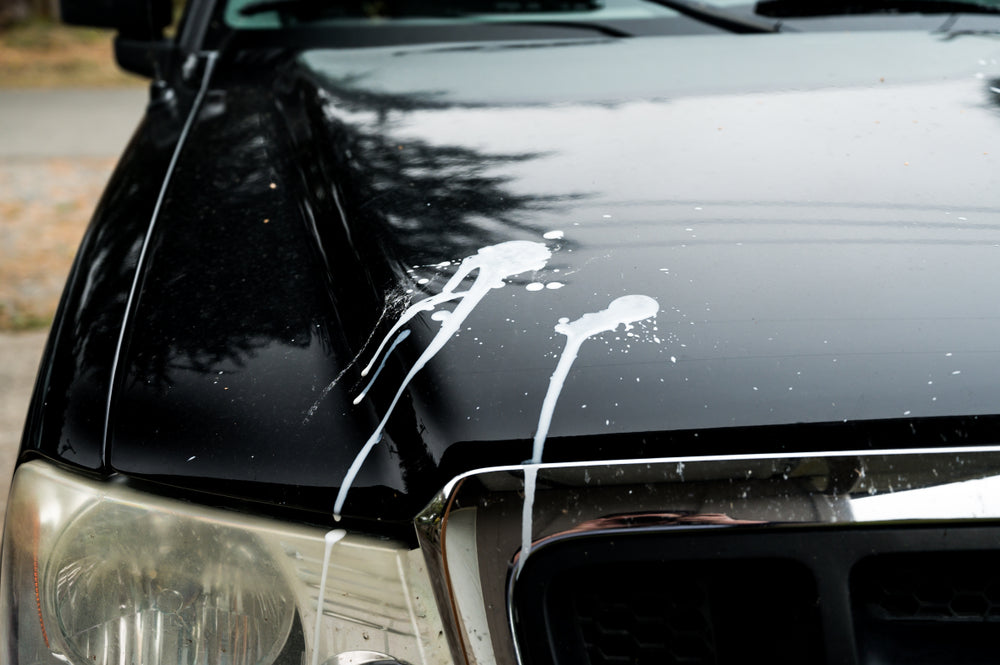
top-left (531, 295), bottom-right (660, 464)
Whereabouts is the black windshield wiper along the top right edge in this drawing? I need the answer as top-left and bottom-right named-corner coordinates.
top-left (754, 0), bottom-right (1000, 18)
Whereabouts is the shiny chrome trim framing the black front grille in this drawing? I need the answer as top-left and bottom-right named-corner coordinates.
top-left (416, 445), bottom-right (1000, 665)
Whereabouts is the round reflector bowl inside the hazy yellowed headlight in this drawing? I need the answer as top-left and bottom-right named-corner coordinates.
top-left (49, 496), bottom-right (295, 665)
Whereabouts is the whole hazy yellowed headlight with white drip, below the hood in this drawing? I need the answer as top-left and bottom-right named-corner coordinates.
top-left (0, 462), bottom-right (450, 665)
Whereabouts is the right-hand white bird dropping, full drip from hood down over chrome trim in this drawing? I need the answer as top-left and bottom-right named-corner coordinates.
top-left (517, 295), bottom-right (660, 574)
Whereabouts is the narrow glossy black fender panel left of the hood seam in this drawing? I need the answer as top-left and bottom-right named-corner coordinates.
top-left (22, 85), bottom-right (184, 471)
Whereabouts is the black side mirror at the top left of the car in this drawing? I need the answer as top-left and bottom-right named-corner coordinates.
top-left (59, 0), bottom-right (174, 78)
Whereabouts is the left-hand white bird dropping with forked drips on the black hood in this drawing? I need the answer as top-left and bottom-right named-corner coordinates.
top-left (333, 240), bottom-right (552, 520)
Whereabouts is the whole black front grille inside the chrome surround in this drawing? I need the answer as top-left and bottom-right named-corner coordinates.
top-left (511, 525), bottom-right (1000, 665)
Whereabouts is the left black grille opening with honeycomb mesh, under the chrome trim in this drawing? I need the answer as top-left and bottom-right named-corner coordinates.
top-left (524, 559), bottom-right (824, 665)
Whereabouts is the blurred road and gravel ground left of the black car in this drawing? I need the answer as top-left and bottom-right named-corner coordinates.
top-left (0, 84), bottom-right (146, 515)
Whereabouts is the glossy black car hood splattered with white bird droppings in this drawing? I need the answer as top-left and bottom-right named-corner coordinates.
top-left (109, 33), bottom-right (1000, 520)
